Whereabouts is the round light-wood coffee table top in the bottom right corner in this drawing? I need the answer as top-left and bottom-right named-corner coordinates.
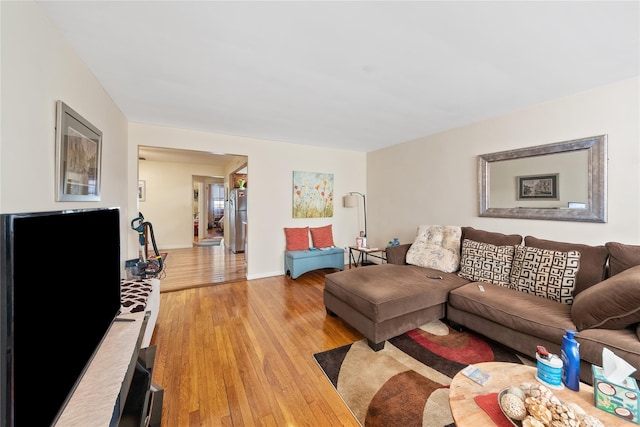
top-left (449, 362), bottom-right (633, 427)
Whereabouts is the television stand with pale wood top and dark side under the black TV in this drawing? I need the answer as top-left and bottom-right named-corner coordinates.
top-left (51, 312), bottom-right (163, 427)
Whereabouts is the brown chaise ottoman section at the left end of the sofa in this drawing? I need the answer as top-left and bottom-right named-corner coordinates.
top-left (323, 264), bottom-right (469, 351)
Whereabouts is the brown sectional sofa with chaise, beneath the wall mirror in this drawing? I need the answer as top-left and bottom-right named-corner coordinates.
top-left (324, 227), bottom-right (640, 384)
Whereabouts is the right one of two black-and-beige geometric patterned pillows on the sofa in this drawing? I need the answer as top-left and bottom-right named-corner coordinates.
top-left (509, 246), bottom-right (580, 305)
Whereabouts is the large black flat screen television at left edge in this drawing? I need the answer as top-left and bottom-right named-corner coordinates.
top-left (0, 208), bottom-right (122, 426)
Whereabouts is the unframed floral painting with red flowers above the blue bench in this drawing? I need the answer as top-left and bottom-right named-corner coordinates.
top-left (293, 171), bottom-right (333, 218)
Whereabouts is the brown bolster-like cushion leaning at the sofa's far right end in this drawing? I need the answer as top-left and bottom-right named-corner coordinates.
top-left (571, 265), bottom-right (640, 331)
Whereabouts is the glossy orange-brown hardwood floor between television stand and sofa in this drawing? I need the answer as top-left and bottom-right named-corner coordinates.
top-left (151, 254), bottom-right (363, 427)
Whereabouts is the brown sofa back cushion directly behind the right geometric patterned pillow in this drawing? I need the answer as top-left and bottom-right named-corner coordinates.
top-left (524, 236), bottom-right (609, 295)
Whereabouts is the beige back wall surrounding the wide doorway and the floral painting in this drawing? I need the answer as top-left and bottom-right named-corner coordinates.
top-left (129, 123), bottom-right (368, 278)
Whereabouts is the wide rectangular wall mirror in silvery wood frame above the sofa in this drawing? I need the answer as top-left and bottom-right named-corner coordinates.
top-left (478, 135), bottom-right (607, 222)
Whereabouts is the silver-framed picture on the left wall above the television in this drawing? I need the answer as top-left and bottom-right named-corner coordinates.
top-left (56, 101), bottom-right (102, 202)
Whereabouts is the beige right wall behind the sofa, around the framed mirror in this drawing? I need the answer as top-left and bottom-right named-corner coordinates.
top-left (367, 77), bottom-right (640, 245)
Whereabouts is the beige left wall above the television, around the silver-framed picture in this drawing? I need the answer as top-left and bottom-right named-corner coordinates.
top-left (0, 1), bottom-right (135, 258)
